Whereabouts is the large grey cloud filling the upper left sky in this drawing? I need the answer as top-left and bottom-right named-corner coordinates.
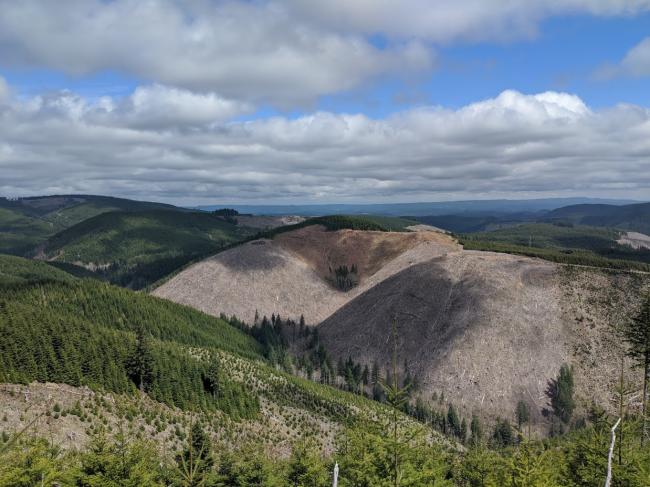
top-left (0, 0), bottom-right (433, 105)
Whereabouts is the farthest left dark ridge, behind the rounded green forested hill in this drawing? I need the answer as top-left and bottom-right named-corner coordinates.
top-left (0, 195), bottom-right (185, 256)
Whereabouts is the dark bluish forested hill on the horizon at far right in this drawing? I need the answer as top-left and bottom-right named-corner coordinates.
top-left (544, 203), bottom-right (650, 234)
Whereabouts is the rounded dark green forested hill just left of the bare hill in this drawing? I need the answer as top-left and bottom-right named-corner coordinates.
top-left (37, 210), bottom-right (254, 289)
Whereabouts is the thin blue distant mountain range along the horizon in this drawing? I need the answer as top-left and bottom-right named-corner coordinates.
top-left (196, 198), bottom-right (638, 216)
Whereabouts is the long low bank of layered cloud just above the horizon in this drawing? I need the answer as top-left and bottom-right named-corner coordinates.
top-left (0, 86), bottom-right (650, 204)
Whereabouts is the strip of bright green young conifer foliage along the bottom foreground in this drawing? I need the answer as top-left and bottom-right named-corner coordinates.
top-left (0, 420), bottom-right (650, 487)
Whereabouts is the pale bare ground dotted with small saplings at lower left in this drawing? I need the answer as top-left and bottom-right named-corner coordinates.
top-left (0, 383), bottom-right (340, 459)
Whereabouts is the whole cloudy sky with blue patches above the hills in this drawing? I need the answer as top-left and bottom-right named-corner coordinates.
top-left (0, 0), bottom-right (650, 205)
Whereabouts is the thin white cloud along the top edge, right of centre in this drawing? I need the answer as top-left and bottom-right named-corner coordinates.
top-left (286, 0), bottom-right (650, 43)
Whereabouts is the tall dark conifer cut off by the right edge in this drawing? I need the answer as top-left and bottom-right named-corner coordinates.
top-left (625, 293), bottom-right (650, 446)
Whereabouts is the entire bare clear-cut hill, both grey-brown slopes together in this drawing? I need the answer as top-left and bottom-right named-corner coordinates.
top-left (154, 224), bottom-right (650, 428)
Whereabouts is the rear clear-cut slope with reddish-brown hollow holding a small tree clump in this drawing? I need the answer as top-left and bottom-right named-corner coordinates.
top-left (154, 225), bottom-right (459, 324)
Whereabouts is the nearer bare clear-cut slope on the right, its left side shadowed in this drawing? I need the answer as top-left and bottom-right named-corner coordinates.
top-left (318, 251), bottom-right (650, 428)
